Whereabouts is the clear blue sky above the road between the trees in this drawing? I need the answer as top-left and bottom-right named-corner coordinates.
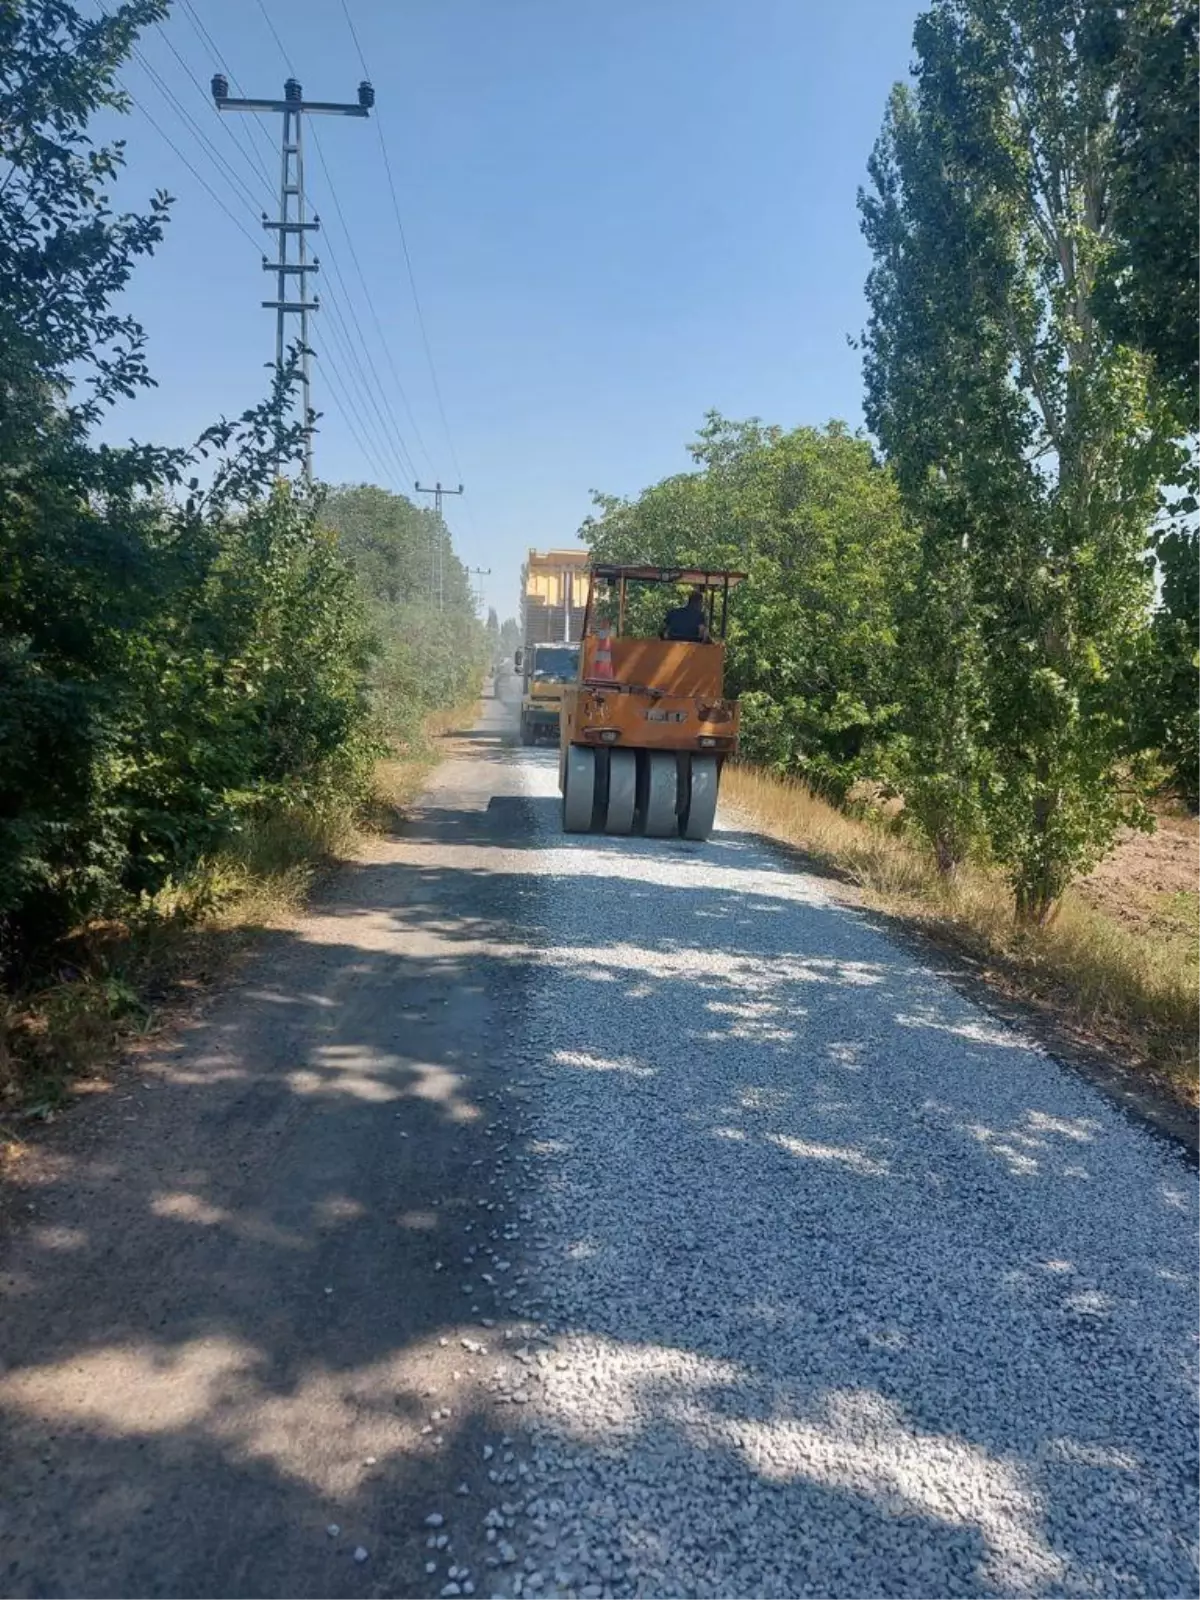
top-left (108, 0), bottom-right (920, 616)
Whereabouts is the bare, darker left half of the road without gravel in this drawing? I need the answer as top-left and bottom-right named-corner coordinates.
top-left (0, 700), bottom-right (550, 1600)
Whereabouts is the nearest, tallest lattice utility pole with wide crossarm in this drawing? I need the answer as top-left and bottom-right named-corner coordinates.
top-left (213, 72), bottom-right (374, 483)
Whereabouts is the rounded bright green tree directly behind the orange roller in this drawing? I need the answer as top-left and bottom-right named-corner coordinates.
top-left (584, 414), bottom-right (914, 797)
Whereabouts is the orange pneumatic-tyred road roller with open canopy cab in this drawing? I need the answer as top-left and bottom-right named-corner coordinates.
top-left (558, 565), bottom-right (746, 840)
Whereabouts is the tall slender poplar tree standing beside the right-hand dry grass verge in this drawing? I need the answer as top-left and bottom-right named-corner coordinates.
top-left (862, 0), bottom-right (1178, 922)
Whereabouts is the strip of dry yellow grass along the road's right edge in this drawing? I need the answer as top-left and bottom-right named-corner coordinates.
top-left (722, 766), bottom-right (1200, 1106)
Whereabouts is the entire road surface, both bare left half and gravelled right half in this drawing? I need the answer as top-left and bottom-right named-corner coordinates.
top-left (0, 709), bottom-right (1200, 1600)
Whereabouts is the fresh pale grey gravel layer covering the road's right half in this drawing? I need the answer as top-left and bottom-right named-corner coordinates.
top-left (467, 757), bottom-right (1200, 1600)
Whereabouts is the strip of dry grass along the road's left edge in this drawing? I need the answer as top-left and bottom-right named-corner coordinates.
top-left (0, 720), bottom-right (460, 1120)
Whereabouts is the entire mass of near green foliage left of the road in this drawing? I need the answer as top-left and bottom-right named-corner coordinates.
top-left (0, 0), bottom-right (466, 966)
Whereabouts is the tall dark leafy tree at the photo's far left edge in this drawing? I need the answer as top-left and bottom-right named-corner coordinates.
top-left (0, 0), bottom-right (181, 958)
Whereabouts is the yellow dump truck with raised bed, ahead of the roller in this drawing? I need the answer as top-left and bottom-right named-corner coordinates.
top-left (514, 550), bottom-right (587, 744)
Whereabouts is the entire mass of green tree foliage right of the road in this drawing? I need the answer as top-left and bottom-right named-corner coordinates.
top-left (584, 0), bottom-right (1200, 922)
